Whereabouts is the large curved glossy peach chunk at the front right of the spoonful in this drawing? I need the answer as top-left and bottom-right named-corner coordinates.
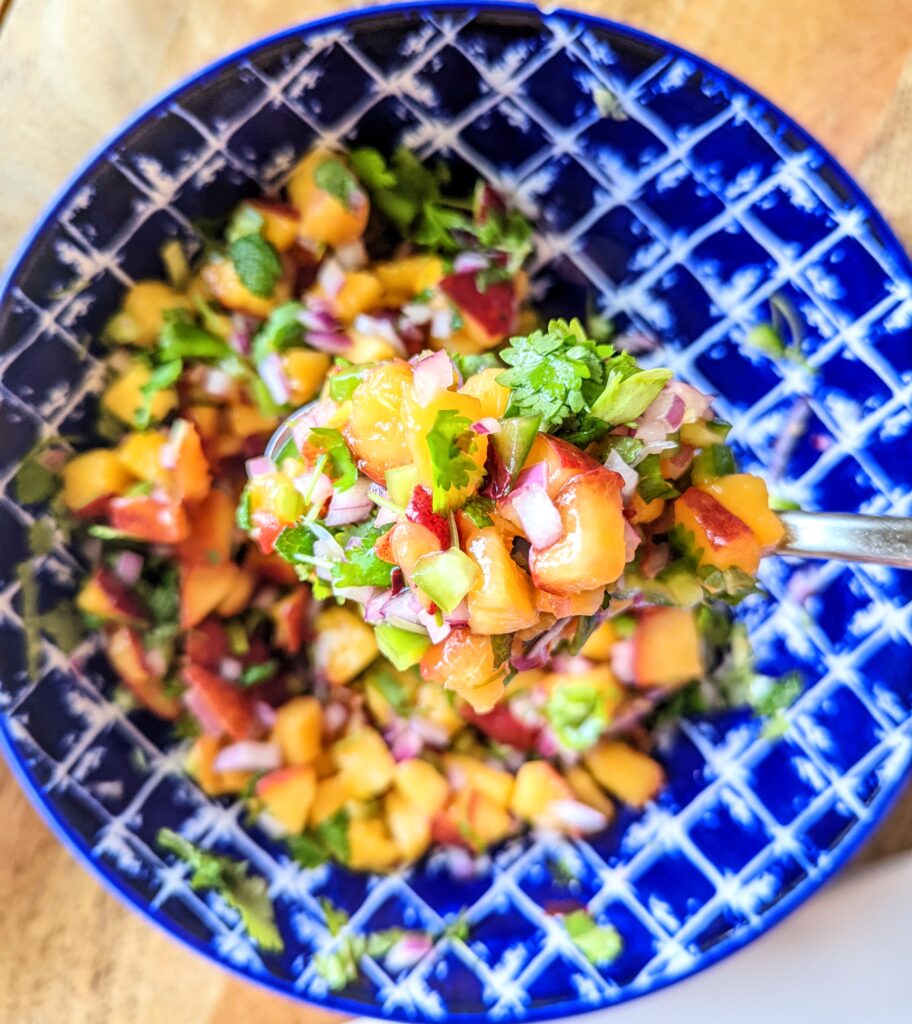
top-left (529, 467), bottom-right (626, 594)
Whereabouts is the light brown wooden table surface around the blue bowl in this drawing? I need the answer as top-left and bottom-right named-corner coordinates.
top-left (0, 0), bottom-right (912, 1024)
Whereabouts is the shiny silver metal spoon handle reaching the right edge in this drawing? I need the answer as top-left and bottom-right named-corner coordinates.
top-left (778, 512), bottom-right (912, 569)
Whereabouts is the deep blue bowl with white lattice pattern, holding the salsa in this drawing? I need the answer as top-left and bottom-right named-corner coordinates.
top-left (0, 4), bottom-right (912, 1021)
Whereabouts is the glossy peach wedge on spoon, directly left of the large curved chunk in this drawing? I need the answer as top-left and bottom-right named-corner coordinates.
top-left (465, 526), bottom-right (538, 634)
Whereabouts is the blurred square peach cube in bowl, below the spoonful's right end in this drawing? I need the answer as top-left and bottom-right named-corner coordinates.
top-left (633, 607), bottom-right (705, 689)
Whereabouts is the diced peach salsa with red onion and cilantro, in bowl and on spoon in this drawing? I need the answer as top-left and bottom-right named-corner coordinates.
top-left (49, 148), bottom-right (795, 888)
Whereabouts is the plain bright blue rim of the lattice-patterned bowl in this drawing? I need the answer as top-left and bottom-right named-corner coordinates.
top-left (0, 0), bottom-right (912, 1024)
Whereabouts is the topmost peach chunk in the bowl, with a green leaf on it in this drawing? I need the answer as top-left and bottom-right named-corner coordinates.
top-left (288, 150), bottom-right (371, 247)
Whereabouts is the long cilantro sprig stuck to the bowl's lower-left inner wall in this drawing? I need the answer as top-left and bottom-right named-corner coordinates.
top-left (158, 828), bottom-right (284, 952)
